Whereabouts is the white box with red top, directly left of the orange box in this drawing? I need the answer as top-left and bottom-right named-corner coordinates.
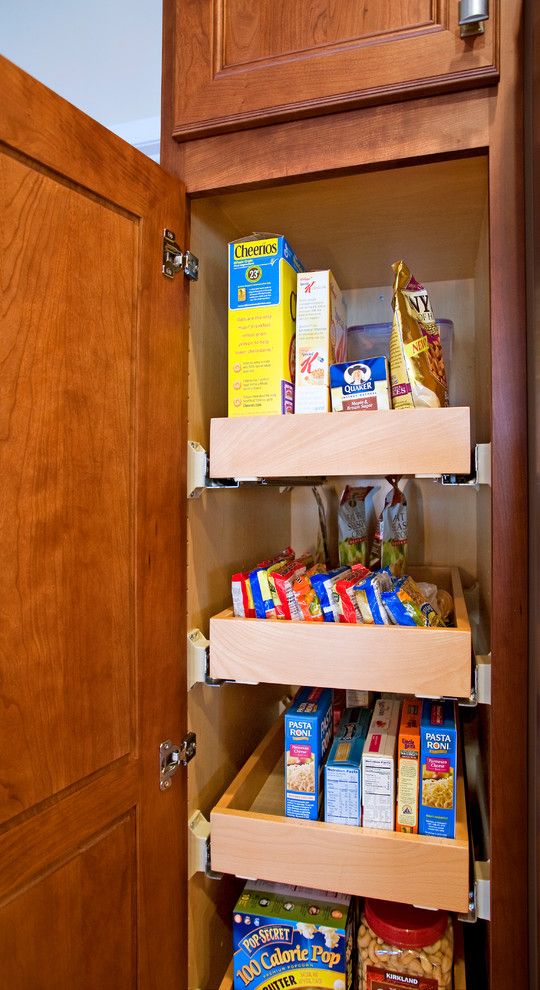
top-left (362, 698), bottom-right (401, 831)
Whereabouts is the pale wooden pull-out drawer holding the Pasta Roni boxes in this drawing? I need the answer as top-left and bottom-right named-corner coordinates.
top-left (211, 719), bottom-right (469, 912)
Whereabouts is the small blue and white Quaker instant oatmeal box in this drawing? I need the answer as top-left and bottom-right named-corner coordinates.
top-left (330, 357), bottom-right (392, 412)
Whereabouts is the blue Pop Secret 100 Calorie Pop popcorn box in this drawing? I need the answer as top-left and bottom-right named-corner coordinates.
top-left (233, 880), bottom-right (356, 990)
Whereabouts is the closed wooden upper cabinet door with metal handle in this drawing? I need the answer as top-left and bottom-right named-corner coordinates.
top-left (171, 0), bottom-right (498, 140)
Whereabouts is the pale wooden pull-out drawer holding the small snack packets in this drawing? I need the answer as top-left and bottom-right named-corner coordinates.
top-left (210, 567), bottom-right (471, 698)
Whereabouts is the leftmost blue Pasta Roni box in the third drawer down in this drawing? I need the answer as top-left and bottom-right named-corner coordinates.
top-left (284, 688), bottom-right (333, 821)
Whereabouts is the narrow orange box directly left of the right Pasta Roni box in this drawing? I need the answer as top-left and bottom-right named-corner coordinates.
top-left (396, 698), bottom-right (422, 832)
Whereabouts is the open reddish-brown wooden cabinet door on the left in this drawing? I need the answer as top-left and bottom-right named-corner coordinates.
top-left (0, 60), bottom-right (187, 990)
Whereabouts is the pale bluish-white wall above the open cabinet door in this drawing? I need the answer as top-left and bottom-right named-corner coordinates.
top-left (0, 0), bottom-right (162, 156)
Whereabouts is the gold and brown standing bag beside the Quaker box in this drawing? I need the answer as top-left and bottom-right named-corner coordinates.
top-left (390, 261), bottom-right (448, 409)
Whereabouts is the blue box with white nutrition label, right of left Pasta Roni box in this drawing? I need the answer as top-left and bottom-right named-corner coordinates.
top-left (324, 708), bottom-right (371, 825)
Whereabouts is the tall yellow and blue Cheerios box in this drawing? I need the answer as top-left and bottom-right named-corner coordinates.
top-left (229, 234), bottom-right (303, 416)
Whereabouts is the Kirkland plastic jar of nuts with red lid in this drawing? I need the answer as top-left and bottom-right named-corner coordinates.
top-left (358, 900), bottom-right (454, 990)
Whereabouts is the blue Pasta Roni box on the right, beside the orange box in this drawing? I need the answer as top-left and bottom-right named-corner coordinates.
top-left (418, 701), bottom-right (457, 839)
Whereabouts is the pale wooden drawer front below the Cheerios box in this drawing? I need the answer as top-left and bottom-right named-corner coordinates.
top-left (210, 406), bottom-right (471, 480)
